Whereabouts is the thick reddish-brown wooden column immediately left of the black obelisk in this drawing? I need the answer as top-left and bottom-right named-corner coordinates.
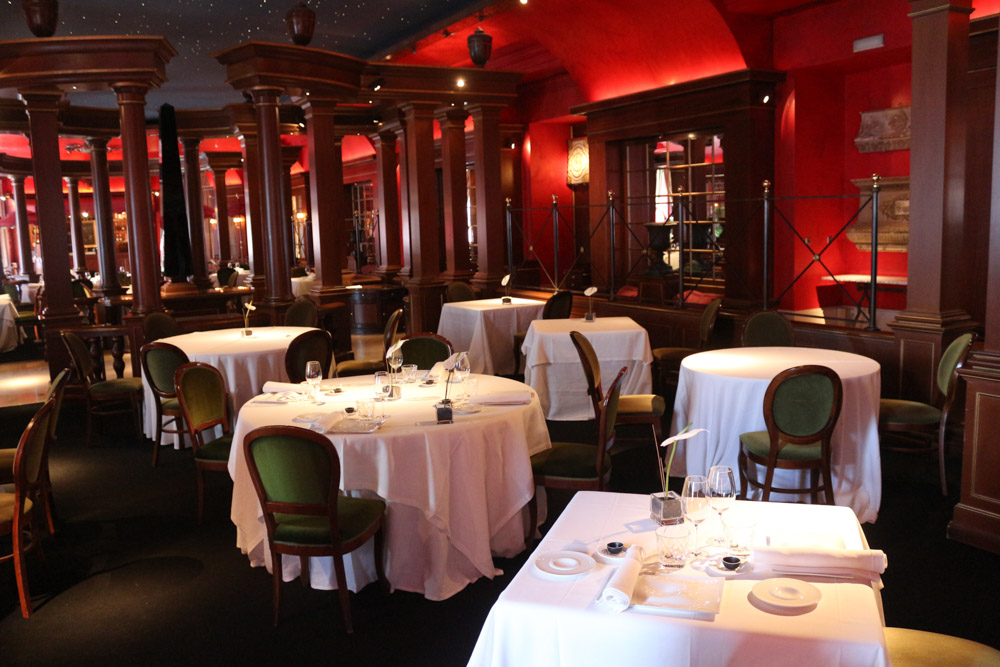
top-left (112, 83), bottom-right (163, 317)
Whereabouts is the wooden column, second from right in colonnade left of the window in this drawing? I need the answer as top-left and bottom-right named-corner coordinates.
top-left (435, 107), bottom-right (472, 282)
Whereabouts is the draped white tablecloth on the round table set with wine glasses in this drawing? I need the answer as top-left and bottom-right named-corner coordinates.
top-left (229, 375), bottom-right (550, 600)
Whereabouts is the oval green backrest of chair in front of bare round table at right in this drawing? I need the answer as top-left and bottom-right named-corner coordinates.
top-left (764, 364), bottom-right (843, 458)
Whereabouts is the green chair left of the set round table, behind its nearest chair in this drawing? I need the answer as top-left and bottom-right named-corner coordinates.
top-left (174, 361), bottom-right (233, 524)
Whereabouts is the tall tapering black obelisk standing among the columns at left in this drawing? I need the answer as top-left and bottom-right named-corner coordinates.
top-left (160, 104), bottom-right (191, 281)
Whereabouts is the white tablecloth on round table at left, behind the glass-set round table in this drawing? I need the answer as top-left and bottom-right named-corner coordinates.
top-left (142, 327), bottom-right (311, 438)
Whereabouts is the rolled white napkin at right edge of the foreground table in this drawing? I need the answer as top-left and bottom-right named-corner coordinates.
top-left (752, 546), bottom-right (888, 580)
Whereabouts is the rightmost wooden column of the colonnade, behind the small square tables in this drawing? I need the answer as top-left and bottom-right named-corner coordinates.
top-left (469, 104), bottom-right (507, 294)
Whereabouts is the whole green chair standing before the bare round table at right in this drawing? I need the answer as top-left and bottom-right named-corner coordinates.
top-left (738, 365), bottom-right (843, 505)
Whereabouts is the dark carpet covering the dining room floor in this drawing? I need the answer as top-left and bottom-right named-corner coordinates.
top-left (0, 403), bottom-right (1000, 666)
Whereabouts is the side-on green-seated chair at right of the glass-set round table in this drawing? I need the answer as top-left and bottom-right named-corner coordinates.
top-left (528, 368), bottom-right (628, 531)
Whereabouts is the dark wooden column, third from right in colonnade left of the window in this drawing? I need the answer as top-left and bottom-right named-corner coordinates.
top-left (401, 102), bottom-right (443, 331)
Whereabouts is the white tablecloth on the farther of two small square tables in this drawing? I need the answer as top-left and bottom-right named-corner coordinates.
top-left (438, 297), bottom-right (545, 375)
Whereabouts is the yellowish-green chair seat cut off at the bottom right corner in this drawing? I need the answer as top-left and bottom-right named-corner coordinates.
top-left (885, 628), bottom-right (1000, 667)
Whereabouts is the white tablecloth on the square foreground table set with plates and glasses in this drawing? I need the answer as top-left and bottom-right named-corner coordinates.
top-left (469, 492), bottom-right (888, 667)
